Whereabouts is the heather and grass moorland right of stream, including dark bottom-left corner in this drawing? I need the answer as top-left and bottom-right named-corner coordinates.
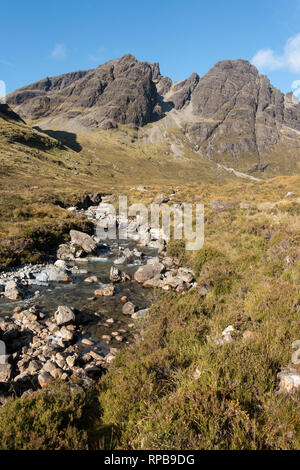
top-left (0, 177), bottom-right (300, 449)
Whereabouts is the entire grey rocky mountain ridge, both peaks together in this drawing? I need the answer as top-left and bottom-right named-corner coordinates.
top-left (8, 55), bottom-right (300, 172)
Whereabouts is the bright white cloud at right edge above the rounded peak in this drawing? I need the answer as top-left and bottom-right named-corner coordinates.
top-left (251, 33), bottom-right (300, 73)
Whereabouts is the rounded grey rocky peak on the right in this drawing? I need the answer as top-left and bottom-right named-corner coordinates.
top-left (189, 60), bottom-right (300, 158)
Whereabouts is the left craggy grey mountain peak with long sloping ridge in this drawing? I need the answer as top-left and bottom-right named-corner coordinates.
top-left (8, 55), bottom-right (157, 129)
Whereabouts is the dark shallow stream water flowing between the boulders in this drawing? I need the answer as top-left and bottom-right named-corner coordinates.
top-left (0, 242), bottom-right (156, 347)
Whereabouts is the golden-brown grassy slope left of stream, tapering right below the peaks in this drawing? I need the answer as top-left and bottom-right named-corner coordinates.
top-left (0, 114), bottom-right (241, 267)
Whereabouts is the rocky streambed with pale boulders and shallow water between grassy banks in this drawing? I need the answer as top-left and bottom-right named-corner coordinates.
top-left (0, 196), bottom-right (195, 405)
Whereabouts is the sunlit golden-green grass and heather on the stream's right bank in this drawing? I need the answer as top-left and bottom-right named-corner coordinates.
top-left (96, 183), bottom-right (300, 449)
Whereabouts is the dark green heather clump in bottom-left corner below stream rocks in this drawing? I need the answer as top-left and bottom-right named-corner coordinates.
top-left (0, 383), bottom-right (106, 450)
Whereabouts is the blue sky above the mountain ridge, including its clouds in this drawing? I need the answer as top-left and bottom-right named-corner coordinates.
top-left (0, 0), bottom-right (300, 92)
